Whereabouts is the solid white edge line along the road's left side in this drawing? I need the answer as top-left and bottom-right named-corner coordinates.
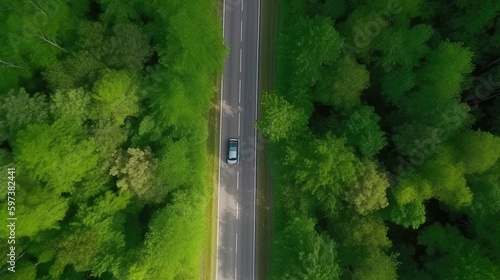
top-left (215, 0), bottom-right (226, 279)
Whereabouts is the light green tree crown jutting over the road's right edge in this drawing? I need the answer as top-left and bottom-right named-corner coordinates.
top-left (256, 93), bottom-right (308, 141)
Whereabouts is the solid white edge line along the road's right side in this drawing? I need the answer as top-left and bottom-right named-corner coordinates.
top-left (252, 0), bottom-right (261, 279)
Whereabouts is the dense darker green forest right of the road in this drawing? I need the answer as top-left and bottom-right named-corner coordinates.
top-left (257, 0), bottom-right (500, 280)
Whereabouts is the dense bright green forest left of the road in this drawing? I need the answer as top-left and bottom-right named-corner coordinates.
top-left (0, 0), bottom-right (227, 280)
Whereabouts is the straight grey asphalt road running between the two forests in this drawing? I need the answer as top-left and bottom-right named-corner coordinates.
top-left (216, 0), bottom-right (260, 280)
